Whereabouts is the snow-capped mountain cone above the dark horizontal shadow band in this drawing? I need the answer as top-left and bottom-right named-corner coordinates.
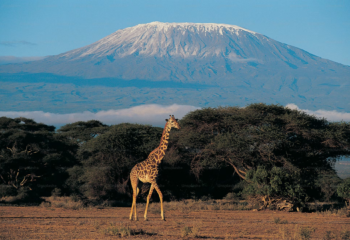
top-left (0, 22), bottom-right (350, 85)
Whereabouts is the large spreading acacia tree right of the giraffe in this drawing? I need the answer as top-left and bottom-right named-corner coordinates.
top-left (175, 104), bottom-right (350, 207)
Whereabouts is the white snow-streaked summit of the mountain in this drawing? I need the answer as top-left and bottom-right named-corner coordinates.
top-left (61, 22), bottom-right (262, 60)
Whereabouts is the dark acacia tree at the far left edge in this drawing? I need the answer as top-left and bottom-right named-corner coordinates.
top-left (0, 117), bottom-right (77, 200)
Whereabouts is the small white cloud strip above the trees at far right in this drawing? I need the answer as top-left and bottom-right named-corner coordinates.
top-left (286, 103), bottom-right (350, 122)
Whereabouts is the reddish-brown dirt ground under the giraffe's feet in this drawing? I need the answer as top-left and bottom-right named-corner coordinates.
top-left (0, 206), bottom-right (350, 239)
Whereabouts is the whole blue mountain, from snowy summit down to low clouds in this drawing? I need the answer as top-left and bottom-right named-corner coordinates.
top-left (0, 22), bottom-right (350, 111)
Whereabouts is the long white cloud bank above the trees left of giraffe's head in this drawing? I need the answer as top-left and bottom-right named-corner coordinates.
top-left (0, 104), bottom-right (199, 126)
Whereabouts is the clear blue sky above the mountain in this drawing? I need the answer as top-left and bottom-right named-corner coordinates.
top-left (0, 0), bottom-right (350, 65)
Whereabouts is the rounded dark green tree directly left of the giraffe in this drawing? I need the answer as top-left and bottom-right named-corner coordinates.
top-left (67, 124), bottom-right (162, 200)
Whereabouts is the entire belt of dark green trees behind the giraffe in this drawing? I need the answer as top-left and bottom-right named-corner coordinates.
top-left (0, 104), bottom-right (350, 211)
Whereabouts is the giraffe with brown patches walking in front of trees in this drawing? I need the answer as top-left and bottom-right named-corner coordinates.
top-left (130, 115), bottom-right (180, 221)
